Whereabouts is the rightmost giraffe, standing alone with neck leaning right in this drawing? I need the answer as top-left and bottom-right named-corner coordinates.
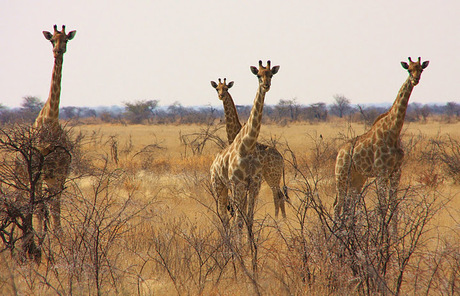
top-left (334, 57), bottom-right (429, 229)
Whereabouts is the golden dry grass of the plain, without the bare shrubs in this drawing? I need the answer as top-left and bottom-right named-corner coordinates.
top-left (0, 122), bottom-right (460, 295)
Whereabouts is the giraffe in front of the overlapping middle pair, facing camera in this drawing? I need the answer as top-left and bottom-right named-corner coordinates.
top-left (211, 61), bottom-right (279, 233)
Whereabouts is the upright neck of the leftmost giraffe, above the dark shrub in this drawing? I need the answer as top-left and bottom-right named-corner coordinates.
top-left (34, 55), bottom-right (63, 128)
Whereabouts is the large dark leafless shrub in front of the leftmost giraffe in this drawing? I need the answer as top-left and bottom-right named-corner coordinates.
top-left (0, 125), bottom-right (78, 262)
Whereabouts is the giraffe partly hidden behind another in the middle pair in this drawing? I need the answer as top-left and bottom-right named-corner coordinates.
top-left (211, 78), bottom-right (287, 218)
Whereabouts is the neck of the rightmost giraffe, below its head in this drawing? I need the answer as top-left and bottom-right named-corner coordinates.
top-left (388, 77), bottom-right (414, 136)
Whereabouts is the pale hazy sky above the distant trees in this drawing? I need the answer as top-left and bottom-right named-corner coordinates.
top-left (0, 0), bottom-right (460, 107)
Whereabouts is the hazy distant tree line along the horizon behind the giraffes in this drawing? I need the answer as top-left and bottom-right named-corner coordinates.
top-left (0, 94), bottom-right (460, 125)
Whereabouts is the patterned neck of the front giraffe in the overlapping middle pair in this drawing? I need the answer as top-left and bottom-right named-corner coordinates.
top-left (239, 85), bottom-right (266, 155)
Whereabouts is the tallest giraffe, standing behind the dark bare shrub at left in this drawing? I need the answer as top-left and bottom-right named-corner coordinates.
top-left (33, 25), bottom-right (76, 231)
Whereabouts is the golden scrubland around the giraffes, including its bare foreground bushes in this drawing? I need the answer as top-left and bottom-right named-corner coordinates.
top-left (0, 121), bottom-right (460, 295)
